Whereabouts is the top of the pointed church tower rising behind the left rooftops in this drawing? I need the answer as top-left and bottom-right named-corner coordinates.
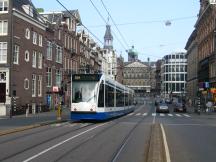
top-left (104, 24), bottom-right (113, 50)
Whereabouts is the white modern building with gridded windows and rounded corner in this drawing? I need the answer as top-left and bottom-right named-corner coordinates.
top-left (161, 53), bottom-right (187, 97)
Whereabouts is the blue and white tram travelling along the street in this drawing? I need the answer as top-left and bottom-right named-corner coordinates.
top-left (71, 74), bottom-right (135, 120)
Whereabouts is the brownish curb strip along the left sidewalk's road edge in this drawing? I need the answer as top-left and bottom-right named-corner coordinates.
top-left (0, 120), bottom-right (68, 136)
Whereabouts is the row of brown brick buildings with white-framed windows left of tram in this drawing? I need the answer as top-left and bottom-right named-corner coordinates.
top-left (0, 0), bottom-right (103, 116)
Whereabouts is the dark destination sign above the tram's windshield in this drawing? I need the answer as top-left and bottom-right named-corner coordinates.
top-left (73, 74), bottom-right (101, 81)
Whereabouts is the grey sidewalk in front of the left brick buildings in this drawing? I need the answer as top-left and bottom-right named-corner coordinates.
top-left (0, 108), bottom-right (70, 134)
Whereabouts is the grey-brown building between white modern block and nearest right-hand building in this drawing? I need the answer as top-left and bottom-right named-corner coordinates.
top-left (185, 30), bottom-right (199, 104)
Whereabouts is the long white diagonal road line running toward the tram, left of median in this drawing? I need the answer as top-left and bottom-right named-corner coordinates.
top-left (23, 123), bottom-right (107, 162)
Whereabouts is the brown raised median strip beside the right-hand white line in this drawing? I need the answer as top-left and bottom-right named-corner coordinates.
top-left (147, 124), bottom-right (166, 162)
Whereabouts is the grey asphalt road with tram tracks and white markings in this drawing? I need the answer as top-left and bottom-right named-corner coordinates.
top-left (0, 98), bottom-right (216, 162)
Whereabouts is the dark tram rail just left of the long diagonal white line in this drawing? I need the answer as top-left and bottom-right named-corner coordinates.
top-left (0, 123), bottom-right (95, 161)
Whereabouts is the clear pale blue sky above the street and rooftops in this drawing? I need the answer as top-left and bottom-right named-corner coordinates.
top-left (32, 0), bottom-right (200, 61)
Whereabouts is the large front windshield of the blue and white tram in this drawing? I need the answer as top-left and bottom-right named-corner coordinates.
top-left (72, 81), bottom-right (98, 103)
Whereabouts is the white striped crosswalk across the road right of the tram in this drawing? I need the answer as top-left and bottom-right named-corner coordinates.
top-left (128, 112), bottom-right (191, 118)
